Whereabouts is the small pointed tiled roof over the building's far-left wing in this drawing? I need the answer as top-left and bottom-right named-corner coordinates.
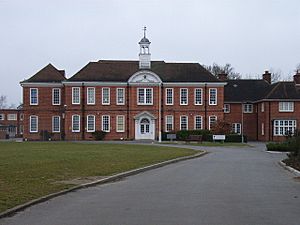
top-left (24, 64), bottom-right (66, 83)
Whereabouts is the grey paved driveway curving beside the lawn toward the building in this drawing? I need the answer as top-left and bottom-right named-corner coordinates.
top-left (0, 144), bottom-right (300, 225)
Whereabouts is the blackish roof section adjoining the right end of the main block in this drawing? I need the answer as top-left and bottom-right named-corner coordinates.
top-left (224, 80), bottom-right (270, 102)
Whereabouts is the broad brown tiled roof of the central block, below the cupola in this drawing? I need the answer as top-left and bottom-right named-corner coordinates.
top-left (69, 60), bottom-right (219, 82)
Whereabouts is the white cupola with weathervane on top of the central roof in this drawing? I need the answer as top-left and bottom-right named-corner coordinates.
top-left (139, 27), bottom-right (151, 69)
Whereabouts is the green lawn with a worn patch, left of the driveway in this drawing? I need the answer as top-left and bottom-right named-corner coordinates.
top-left (0, 142), bottom-right (195, 212)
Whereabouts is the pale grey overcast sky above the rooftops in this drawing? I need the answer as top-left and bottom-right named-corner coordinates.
top-left (0, 0), bottom-right (300, 104)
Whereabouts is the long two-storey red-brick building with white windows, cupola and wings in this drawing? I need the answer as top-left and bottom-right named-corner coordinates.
top-left (15, 32), bottom-right (300, 141)
